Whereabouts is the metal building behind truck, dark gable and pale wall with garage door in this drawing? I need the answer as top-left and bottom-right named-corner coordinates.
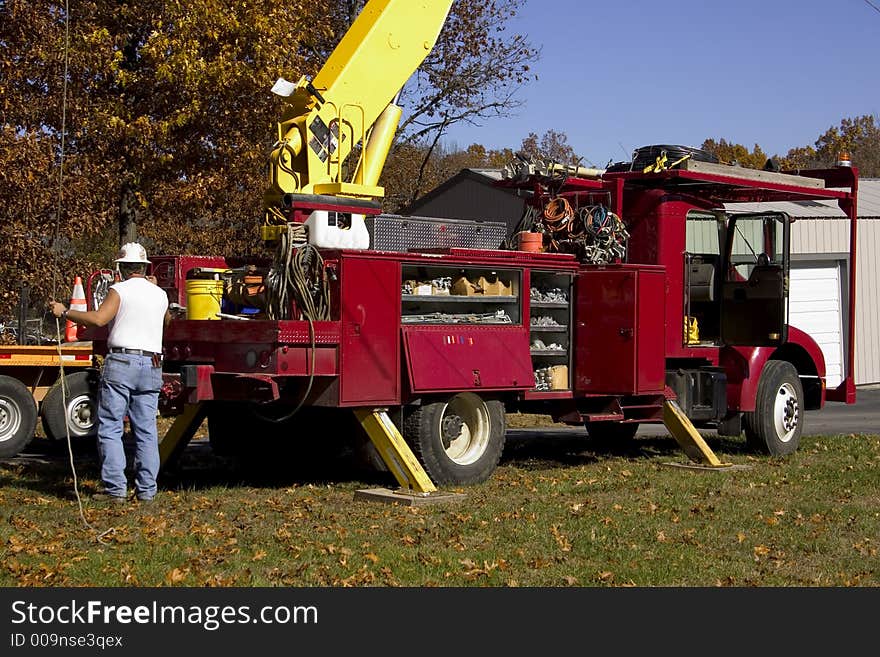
top-left (404, 169), bottom-right (880, 387)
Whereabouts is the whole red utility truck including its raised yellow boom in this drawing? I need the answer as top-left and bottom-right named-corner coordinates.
top-left (81, 0), bottom-right (858, 484)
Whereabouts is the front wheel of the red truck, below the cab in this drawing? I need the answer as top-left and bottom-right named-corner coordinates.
top-left (743, 360), bottom-right (804, 456)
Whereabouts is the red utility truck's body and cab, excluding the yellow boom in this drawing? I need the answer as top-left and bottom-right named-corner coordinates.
top-left (129, 154), bottom-right (857, 484)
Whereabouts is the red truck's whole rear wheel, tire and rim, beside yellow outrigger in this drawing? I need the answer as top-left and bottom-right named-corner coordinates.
top-left (404, 392), bottom-right (507, 485)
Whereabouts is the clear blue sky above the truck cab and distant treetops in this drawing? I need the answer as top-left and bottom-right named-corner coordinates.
top-left (447, 0), bottom-right (880, 167)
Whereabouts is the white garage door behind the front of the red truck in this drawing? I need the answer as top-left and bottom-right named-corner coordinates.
top-left (788, 260), bottom-right (843, 388)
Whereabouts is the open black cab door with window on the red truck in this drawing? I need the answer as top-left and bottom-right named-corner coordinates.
top-left (721, 212), bottom-right (791, 346)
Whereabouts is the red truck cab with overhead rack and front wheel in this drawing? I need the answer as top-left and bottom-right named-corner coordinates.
top-left (607, 162), bottom-right (857, 455)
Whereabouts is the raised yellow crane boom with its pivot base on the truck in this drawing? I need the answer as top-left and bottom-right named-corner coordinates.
top-left (265, 0), bottom-right (453, 223)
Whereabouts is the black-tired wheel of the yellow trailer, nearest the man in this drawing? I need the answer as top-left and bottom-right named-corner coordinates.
top-left (40, 371), bottom-right (98, 441)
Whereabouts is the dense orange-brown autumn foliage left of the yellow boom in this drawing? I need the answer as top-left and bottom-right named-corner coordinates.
top-left (0, 0), bottom-right (331, 312)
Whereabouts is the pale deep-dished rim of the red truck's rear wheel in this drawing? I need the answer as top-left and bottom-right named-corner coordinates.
top-left (440, 392), bottom-right (491, 465)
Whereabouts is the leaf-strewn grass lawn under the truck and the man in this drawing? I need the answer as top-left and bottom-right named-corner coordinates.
top-left (0, 420), bottom-right (880, 587)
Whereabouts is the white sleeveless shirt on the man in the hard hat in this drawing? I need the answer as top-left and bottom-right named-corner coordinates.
top-left (107, 277), bottom-right (168, 353)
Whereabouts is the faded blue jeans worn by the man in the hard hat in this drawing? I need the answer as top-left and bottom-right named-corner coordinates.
top-left (98, 354), bottom-right (162, 499)
